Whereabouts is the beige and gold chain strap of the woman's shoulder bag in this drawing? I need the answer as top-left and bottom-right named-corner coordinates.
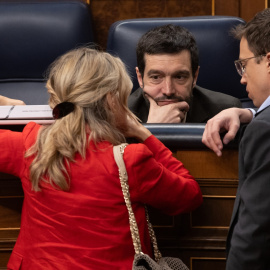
top-left (113, 144), bottom-right (162, 261)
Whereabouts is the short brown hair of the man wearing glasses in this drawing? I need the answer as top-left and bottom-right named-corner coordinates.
top-left (232, 8), bottom-right (270, 59)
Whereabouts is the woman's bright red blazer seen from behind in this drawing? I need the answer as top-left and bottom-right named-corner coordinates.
top-left (0, 123), bottom-right (202, 270)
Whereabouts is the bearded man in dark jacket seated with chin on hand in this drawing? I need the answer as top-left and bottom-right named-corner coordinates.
top-left (128, 24), bottom-right (241, 123)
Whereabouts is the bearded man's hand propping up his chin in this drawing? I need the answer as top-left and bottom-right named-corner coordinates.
top-left (146, 94), bottom-right (189, 123)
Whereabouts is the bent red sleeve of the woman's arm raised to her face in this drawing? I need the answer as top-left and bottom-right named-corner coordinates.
top-left (124, 136), bottom-right (202, 215)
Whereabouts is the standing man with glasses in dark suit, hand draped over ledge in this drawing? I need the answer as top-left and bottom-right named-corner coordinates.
top-left (203, 9), bottom-right (270, 270)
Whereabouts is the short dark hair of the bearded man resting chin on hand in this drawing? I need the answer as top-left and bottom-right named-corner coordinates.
top-left (136, 24), bottom-right (199, 77)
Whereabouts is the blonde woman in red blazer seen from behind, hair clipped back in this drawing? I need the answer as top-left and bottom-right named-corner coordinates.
top-left (3, 48), bottom-right (202, 270)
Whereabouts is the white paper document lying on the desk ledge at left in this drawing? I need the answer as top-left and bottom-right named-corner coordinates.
top-left (0, 105), bottom-right (53, 120)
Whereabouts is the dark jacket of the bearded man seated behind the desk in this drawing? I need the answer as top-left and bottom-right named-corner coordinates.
top-left (128, 85), bottom-right (242, 123)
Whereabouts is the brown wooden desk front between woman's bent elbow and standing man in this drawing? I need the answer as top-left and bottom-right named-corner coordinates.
top-left (151, 149), bottom-right (238, 270)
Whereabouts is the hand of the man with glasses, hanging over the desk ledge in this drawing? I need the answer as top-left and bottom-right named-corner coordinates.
top-left (202, 108), bottom-right (253, 156)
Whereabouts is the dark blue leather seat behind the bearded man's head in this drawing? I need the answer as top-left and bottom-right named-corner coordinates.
top-left (107, 16), bottom-right (254, 107)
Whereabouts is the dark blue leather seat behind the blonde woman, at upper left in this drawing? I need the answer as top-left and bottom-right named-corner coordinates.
top-left (0, 0), bottom-right (94, 105)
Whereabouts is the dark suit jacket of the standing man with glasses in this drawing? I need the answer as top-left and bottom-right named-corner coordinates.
top-left (226, 106), bottom-right (270, 270)
